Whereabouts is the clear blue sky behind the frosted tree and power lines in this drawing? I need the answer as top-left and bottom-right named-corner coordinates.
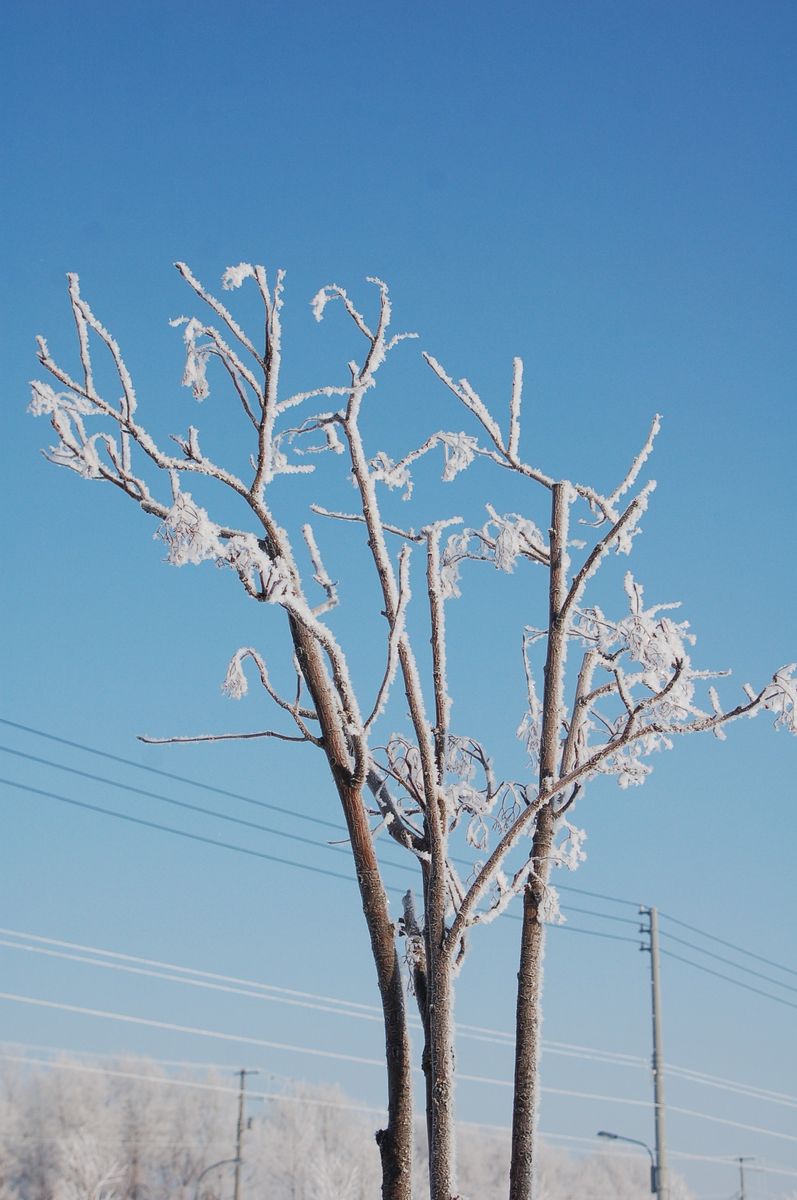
top-left (0, 0), bottom-right (797, 1196)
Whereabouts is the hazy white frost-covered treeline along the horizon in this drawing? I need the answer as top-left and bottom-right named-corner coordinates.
top-left (0, 1057), bottom-right (689, 1200)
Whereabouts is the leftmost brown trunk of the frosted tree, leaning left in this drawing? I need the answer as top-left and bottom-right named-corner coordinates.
top-left (290, 619), bottom-right (413, 1200)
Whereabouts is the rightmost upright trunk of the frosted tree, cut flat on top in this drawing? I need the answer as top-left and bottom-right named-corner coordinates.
top-left (509, 484), bottom-right (569, 1200)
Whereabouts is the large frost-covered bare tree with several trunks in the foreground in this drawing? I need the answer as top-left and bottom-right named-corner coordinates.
top-left (31, 263), bottom-right (797, 1200)
